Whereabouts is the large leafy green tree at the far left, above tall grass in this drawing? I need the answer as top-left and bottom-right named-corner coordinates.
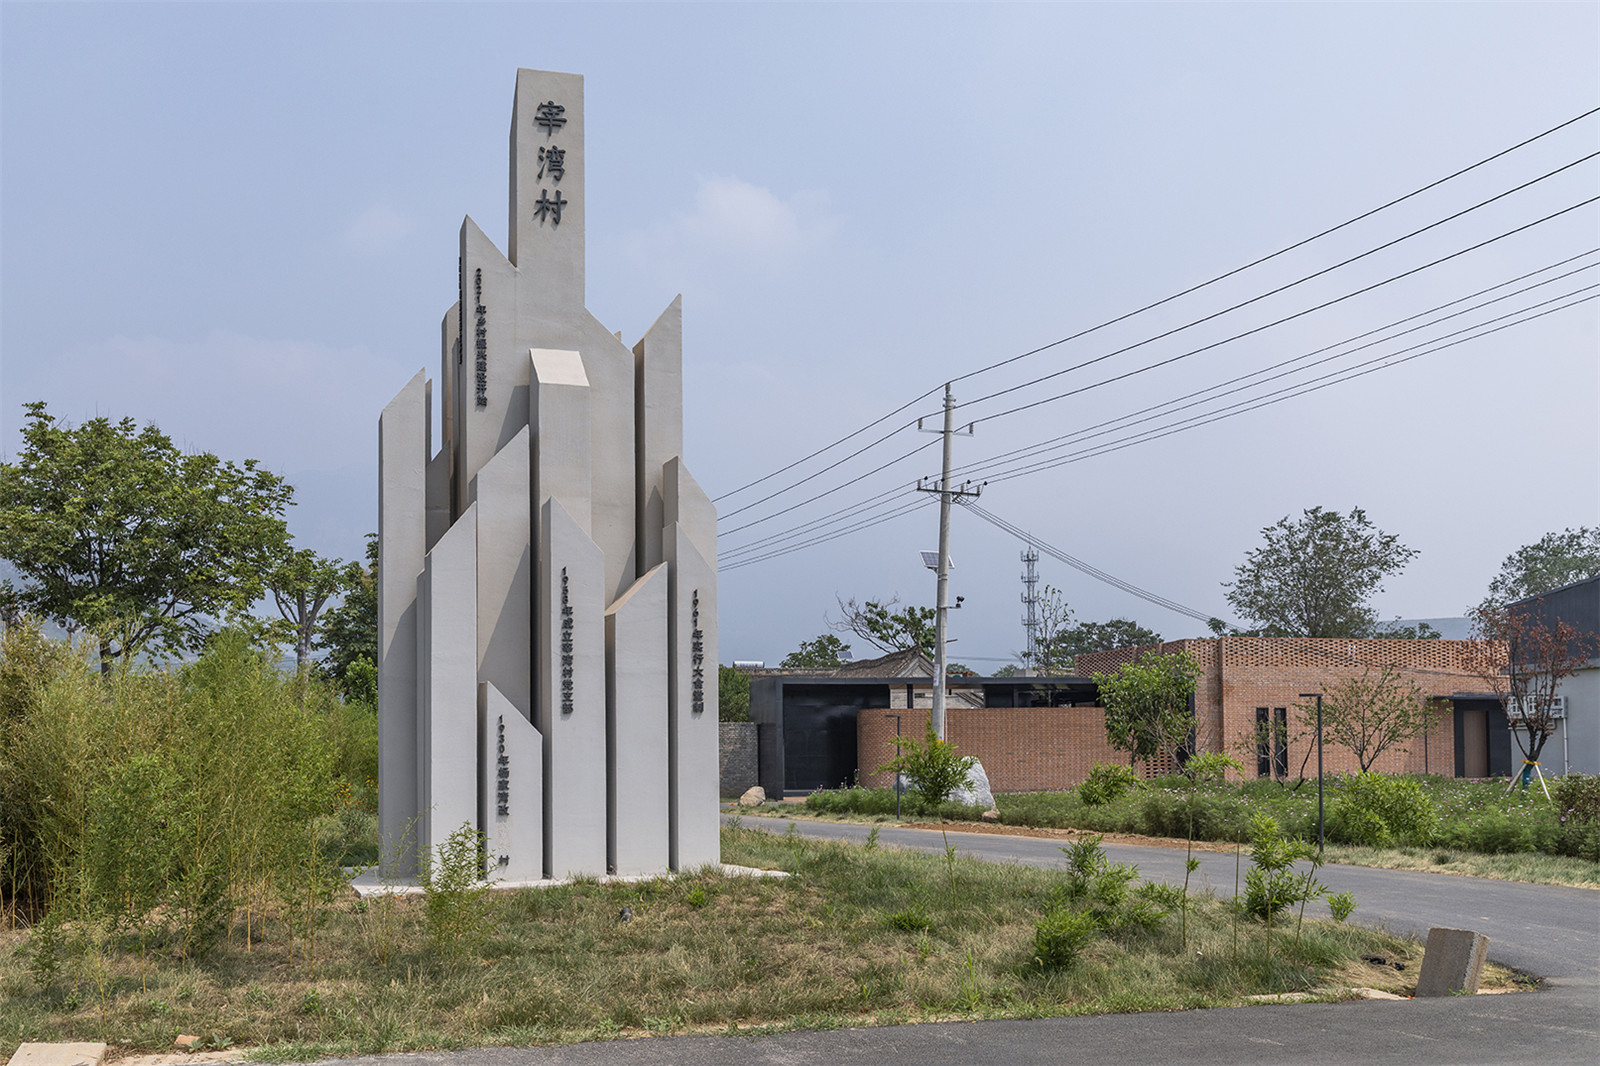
top-left (0, 402), bottom-right (294, 674)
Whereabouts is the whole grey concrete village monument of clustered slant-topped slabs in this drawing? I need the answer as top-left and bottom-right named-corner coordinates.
top-left (378, 70), bottom-right (720, 882)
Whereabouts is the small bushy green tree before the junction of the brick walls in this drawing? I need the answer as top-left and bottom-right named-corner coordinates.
top-left (1094, 651), bottom-right (1200, 765)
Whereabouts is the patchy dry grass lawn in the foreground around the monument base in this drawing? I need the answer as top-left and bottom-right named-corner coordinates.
top-left (0, 828), bottom-right (1504, 1061)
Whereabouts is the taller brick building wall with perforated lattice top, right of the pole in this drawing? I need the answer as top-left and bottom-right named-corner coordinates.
top-left (1078, 637), bottom-right (1483, 776)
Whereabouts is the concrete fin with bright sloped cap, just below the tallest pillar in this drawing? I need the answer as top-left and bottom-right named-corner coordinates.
top-left (528, 347), bottom-right (594, 536)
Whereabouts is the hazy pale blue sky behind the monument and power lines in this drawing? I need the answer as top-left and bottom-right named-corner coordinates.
top-left (0, 2), bottom-right (1600, 672)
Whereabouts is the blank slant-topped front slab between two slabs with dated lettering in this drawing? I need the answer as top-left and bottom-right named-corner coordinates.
top-left (605, 565), bottom-right (670, 874)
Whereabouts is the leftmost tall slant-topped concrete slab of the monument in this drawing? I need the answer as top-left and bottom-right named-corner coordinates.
top-left (376, 370), bottom-right (429, 876)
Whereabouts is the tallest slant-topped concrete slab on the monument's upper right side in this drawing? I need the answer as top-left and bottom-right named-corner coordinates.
top-left (634, 295), bottom-right (683, 573)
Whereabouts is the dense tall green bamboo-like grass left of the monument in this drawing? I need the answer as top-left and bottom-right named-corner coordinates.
top-left (0, 626), bottom-right (376, 956)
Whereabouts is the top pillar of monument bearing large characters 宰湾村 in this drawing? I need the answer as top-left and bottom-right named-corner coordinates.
top-left (506, 70), bottom-right (586, 321)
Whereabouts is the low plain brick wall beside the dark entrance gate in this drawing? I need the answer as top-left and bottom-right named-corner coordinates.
top-left (856, 707), bottom-right (1128, 792)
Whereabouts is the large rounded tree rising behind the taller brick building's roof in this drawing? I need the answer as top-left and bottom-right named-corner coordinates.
top-left (1222, 507), bottom-right (1416, 637)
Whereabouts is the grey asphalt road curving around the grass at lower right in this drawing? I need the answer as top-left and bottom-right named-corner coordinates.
top-left (315, 818), bottom-right (1600, 1066)
